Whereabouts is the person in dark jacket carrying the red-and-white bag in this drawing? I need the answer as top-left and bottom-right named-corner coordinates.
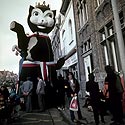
top-left (65, 72), bottom-right (83, 122)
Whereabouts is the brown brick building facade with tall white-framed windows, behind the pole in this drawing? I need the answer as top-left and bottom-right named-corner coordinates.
top-left (73, 0), bottom-right (125, 94)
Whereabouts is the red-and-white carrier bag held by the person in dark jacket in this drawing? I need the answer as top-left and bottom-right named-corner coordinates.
top-left (69, 96), bottom-right (78, 111)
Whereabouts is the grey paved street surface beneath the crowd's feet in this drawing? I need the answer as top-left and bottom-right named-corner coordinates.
top-left (12, 99), bottom-right (125, 125)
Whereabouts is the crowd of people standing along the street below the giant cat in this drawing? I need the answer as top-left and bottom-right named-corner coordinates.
top-left (0, 65), bottom-right (125, 125)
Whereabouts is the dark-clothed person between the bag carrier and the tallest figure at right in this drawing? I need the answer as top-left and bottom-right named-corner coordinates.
top-left (86, 73), bottom-right (105, 125)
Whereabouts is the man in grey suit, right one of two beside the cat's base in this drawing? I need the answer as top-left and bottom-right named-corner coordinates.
top-left (36, 77), bottom-right (46, 111)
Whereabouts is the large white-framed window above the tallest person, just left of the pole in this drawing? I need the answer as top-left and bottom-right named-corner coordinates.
top-left (99, 21), bottom-right (118, 71)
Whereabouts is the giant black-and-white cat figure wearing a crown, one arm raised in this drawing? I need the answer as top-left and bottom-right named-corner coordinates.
top-left (10, 1), bottom-right (64, 107)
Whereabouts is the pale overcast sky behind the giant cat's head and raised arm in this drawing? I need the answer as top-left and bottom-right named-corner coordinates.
top-left (0, 0), bottom-right (62, 73)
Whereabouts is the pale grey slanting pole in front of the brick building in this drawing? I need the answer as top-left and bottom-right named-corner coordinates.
top-left (111, 0), bottom-right (125, 80)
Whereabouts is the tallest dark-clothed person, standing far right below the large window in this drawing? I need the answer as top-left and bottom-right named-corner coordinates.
top-left (105, 65), bottom-right (124, 125)
